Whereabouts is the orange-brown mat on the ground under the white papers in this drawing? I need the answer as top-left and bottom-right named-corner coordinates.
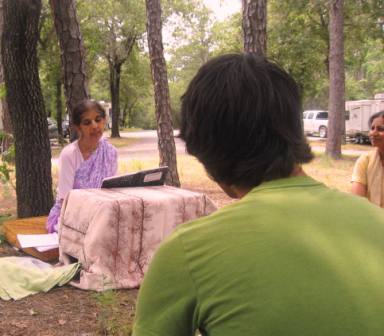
top-left (3, 216), bottom-right (59, 261)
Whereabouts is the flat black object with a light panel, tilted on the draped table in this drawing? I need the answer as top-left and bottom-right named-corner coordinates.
top-left (101, 167), bottom-right (169, 188)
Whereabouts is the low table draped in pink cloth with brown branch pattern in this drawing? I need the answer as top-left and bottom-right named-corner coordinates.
top-left (59, 186), bottom-right (216, 291)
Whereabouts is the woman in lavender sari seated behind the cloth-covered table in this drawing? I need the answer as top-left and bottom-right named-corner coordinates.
top-left (47, 100), bottom-right (117, 233)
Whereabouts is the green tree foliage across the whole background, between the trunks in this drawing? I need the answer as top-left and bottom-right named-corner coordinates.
top-left (35, 0), bottom-right (384, 133)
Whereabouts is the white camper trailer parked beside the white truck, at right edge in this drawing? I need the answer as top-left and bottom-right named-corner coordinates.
top-left (345, 93), bottom-right (384, 143)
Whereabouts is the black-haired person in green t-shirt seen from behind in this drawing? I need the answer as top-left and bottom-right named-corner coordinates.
top-left (133, 54), bottom-right (384, 336)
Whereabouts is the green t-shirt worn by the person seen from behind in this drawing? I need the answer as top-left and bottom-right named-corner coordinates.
top-left (134, 177), bottom-right (384, 336)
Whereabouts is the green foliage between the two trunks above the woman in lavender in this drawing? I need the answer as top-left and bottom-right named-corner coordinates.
top-left (78, 0), bottom-right (156, 129)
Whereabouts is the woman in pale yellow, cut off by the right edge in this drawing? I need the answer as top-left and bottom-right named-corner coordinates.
top-left (352, 111), bottom-right (384, 208)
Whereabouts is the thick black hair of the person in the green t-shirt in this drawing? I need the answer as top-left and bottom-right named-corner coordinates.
top-left (180, 54), bottom-right (313, 187)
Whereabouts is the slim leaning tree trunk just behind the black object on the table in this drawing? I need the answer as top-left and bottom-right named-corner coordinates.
top-left (146, 0), bottom-right (180, 187)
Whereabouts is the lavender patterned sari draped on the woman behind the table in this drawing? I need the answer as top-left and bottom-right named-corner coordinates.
top-left (47, 138), bottom-right (117, 233)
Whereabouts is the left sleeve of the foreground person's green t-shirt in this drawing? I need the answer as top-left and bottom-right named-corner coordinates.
top-left (133, 232), bottom-right (197, 336)
